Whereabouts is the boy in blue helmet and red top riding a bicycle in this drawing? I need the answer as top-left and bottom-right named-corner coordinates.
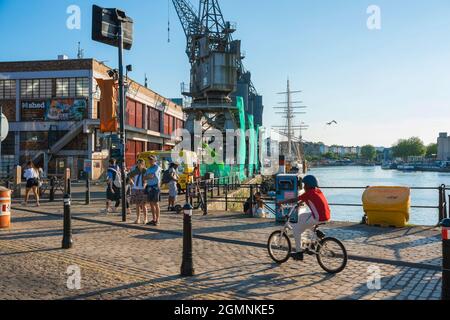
top-left (279, 175), bottom-right (331, 260)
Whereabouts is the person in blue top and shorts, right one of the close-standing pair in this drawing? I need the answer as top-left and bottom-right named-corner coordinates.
top-left (144, 156), bottom-right (161, 226)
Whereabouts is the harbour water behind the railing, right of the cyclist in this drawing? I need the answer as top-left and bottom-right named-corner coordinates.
top-left (298, 166), bottom-right (450, 226)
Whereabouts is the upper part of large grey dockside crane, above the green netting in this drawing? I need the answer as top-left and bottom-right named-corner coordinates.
top-left (172, 0), bottom-right (263, 132)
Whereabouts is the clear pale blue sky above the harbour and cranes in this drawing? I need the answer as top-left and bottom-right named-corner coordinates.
top-left (0, 0), bottom-right (450, 147)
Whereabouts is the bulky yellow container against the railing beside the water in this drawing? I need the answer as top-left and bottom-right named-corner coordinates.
top-left (362, 187), bottom-right (411, 228)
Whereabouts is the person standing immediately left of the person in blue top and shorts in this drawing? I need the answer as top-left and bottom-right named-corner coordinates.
top-left (130, 159), bottom-right (148, 224)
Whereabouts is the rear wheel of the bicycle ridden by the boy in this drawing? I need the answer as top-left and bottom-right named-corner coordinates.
top-left (317, 238), bottom-right (348, 274)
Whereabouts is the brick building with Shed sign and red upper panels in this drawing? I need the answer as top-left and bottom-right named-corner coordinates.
top-left (0, 59), bottom-right (184, 179)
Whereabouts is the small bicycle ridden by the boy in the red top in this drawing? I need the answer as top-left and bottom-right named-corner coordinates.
top-left (267, 203), bottom-right (348, 274)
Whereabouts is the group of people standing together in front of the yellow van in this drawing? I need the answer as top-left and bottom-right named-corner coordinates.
top-left (105, 156), bottom-right (179, 226)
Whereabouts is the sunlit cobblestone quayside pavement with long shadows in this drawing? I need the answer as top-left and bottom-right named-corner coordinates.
top-left (0, 201), bottom-right (442, 300)
